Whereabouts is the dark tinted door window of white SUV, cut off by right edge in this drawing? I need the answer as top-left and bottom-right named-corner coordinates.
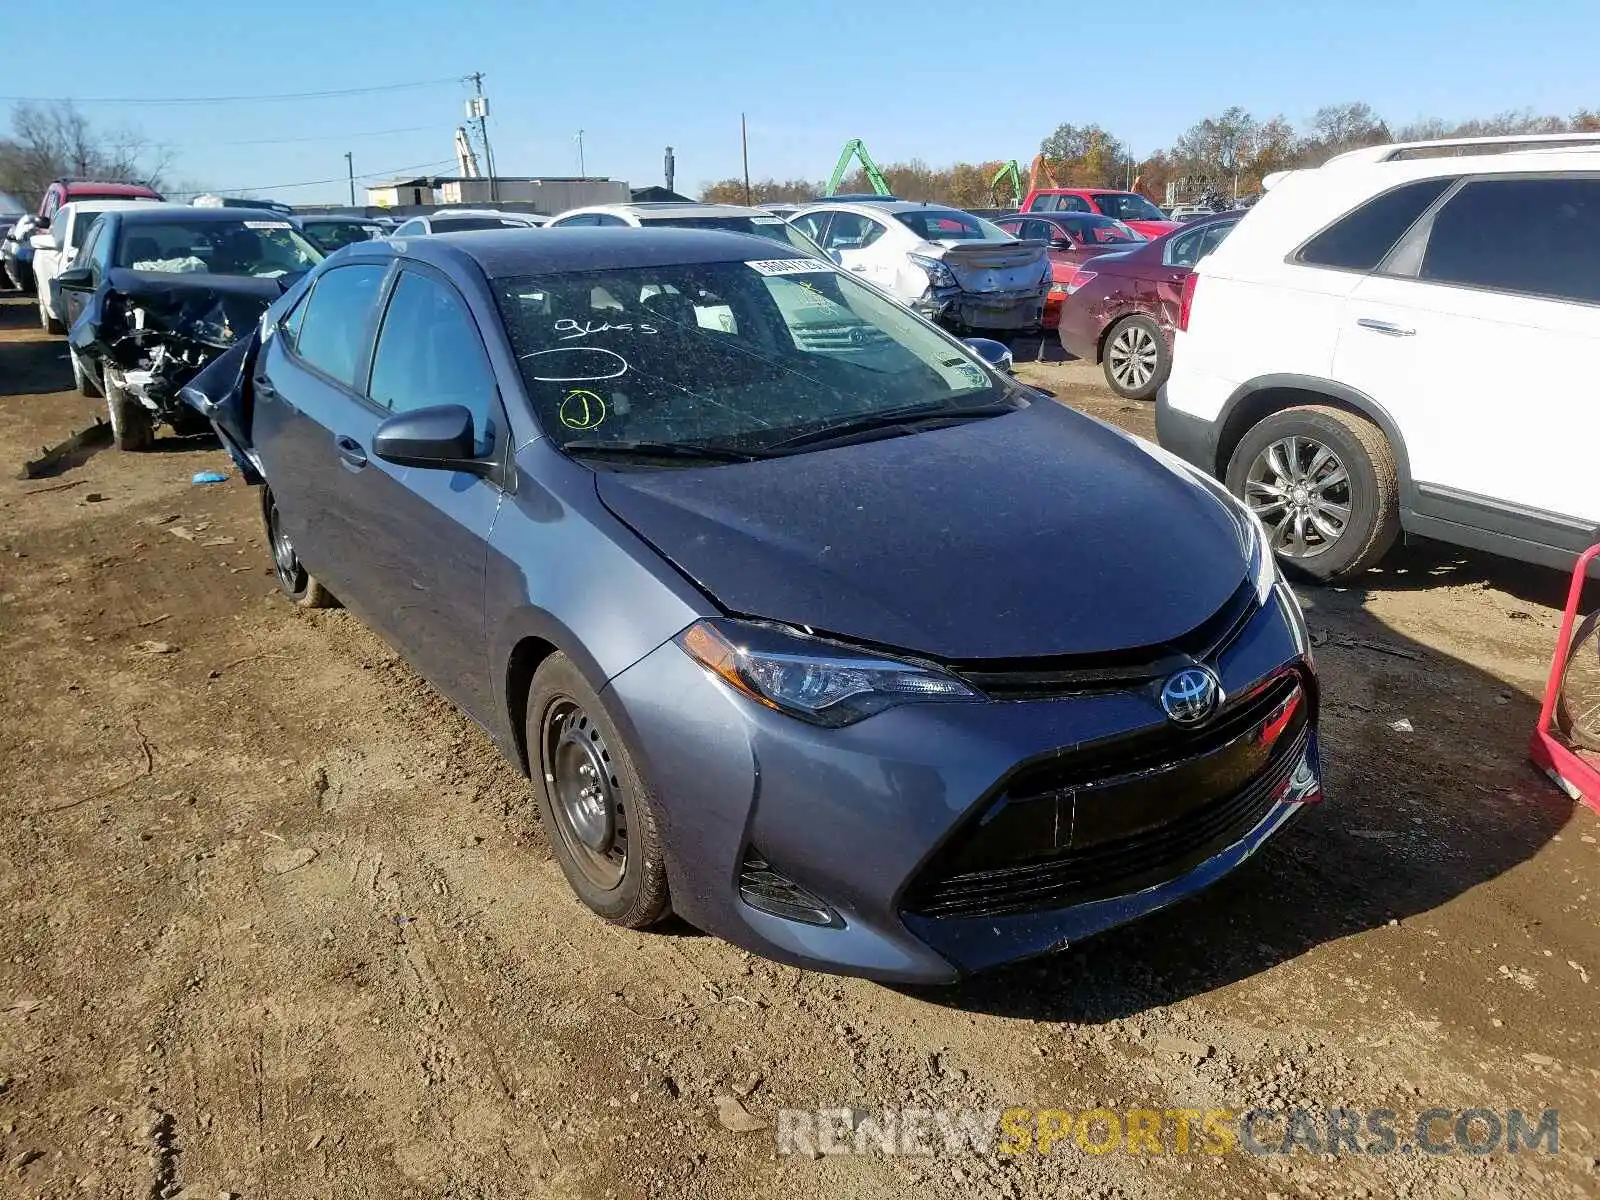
top-left (1418, 179), bottom-right (1600, 304)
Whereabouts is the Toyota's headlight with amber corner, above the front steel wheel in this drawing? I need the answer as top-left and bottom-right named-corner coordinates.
top-left (677, 619), bottom-right (981, 728)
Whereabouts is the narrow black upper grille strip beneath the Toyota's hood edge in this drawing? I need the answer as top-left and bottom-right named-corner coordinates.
top-left (946, 579), bottom-right (1261, 699)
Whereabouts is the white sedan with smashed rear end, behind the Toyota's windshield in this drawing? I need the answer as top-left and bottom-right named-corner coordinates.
top-left (789, 200), bottom-right (1050, 333)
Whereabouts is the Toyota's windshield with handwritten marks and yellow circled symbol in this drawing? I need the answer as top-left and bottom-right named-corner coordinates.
top-left (496, 258), bottom-right (1016, 454)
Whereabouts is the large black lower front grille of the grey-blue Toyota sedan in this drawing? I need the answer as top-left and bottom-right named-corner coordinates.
top-left (902, 672), bottom-right (1310, 917)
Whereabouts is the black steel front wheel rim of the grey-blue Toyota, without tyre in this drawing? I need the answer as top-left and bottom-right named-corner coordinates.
top-left (541, 696), bottom-right (627, 891)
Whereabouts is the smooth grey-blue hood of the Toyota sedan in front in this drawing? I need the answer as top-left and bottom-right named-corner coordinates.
top-left (595, 402), bottom-right (1246, 659)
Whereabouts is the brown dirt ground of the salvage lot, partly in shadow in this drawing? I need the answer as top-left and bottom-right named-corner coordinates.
top-left (0, 301), bottom-right (1600, 1200)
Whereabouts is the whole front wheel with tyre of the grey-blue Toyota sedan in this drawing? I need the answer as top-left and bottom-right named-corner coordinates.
top-left (525, 654), bottom-right (672, 930)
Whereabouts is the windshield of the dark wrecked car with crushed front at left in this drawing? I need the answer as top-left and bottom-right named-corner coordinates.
top-left (117, 218), bottom-right (323, 278)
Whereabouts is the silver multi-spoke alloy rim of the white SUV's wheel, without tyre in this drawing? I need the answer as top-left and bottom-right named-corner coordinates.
top-left (1245, 435), bottom-right (1352, 558)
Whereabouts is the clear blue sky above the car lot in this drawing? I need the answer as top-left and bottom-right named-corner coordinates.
top-left (12, 0), bottom-right (1600, 203)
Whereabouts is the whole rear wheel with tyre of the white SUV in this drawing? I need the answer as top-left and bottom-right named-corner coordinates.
top-left (1227, 405), bottom-right (1400, 579)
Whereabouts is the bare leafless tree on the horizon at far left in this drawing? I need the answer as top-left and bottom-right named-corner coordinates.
top-left (0, 101), bottom-right (173, 205)
